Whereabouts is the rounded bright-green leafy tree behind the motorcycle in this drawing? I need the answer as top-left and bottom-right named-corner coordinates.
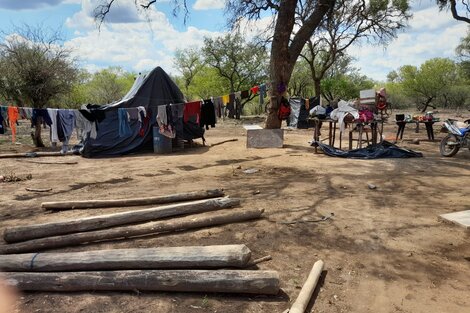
top-left (398, 58), bottom-right (458, 112)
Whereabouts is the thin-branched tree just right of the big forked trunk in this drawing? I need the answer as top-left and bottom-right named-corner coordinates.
top-left (300, 0), bottom-right (410, 96)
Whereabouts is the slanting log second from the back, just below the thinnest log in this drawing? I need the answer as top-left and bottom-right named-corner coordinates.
top-left (3, 198), bottom-right (240, 243)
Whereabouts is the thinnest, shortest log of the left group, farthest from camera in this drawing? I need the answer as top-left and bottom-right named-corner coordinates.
top-left (41, 189), bottom-right (224, 211)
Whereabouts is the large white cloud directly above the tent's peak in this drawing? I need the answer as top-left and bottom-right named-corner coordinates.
top-left (65, 0), bottom-right (220, 73)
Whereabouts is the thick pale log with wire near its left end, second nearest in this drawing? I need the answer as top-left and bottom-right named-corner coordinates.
top-left (0, 245), bottom-right (251, 272)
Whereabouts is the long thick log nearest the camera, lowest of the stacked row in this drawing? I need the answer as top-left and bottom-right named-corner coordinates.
top-left (3, 270), bottom-right (279, 295)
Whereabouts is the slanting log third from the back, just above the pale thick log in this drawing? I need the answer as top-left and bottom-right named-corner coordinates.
top-left (0, 209), bottom-right (264, 254)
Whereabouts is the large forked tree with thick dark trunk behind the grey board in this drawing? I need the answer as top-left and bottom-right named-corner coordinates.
top-left (95, 0), bottom-right (336, 128)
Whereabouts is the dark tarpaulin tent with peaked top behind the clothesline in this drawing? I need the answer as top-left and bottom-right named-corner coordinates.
top-left (80, 67), bottom-right (185, 157)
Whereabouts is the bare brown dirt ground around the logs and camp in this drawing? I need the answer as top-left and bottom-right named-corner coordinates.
top-left (0, 111), bottom-right (470, 313)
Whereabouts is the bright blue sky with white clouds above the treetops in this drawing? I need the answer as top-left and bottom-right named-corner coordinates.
top-left (0, 0), bottom-right (468, 81)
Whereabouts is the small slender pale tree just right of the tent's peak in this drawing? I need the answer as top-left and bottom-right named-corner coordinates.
top-left (174, 48), bottom-right (204, 94)
